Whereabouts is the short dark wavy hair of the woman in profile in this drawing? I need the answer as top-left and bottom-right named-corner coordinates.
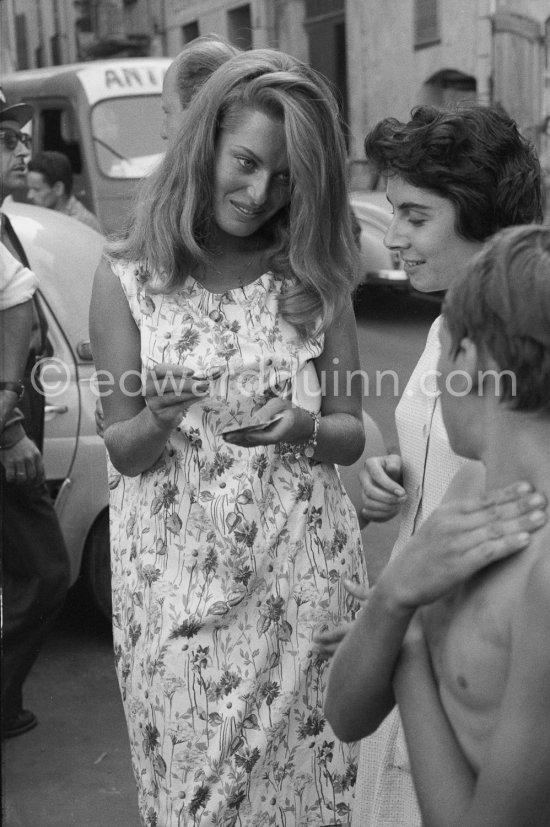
top-left (365, 105), bottom-right (544, 241)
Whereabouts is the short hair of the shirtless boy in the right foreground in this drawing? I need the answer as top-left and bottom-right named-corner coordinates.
top-left (443, 225), bottom-right (550, 413)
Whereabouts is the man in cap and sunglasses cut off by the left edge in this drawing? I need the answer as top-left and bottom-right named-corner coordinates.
top-left (0, 94), bottom-right (69, 738)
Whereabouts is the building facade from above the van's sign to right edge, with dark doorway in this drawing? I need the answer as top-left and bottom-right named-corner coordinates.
top-left (154, 0), bottom-right (550, 186)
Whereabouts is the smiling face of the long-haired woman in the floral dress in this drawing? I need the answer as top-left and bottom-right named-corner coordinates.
top-left (213, 109), bottom-right (290, 238)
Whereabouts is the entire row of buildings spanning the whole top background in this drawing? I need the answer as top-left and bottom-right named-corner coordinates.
top-left (0, 0), bottom-right (550, 185)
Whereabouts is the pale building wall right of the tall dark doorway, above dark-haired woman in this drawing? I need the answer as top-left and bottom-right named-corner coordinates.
top-left (347, 0), bottom-right (550, 183)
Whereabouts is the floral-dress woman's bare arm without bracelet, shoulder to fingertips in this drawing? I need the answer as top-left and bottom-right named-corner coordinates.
top-left (90, 261), bottom-right (205, 476)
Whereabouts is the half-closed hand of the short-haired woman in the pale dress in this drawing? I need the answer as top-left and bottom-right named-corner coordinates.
top-left (359, 454), bottom-right (407, 527)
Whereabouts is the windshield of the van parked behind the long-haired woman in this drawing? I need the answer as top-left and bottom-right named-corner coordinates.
top-left (91, 95), bottom-right (166, 178)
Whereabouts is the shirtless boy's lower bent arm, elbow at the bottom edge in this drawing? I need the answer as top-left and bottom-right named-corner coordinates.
top-left (394, 556), bottom-right (550, 827)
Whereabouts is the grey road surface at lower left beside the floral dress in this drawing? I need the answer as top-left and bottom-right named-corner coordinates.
top-left (2, 594), bottom-right (140, 827)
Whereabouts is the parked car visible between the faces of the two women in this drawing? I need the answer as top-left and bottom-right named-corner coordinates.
top-left (350, 191), bottom-right (411, 291)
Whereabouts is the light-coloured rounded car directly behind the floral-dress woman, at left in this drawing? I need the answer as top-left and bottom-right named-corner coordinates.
top-left (4, 202), bottom-right (111, 616)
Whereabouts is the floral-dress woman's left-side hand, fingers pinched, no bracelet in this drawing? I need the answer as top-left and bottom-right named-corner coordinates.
top-left (143, 362), bottom-right (219, 430)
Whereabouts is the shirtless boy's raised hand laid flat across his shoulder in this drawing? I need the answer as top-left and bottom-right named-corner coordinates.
top-left (376, 482), bottom-right (547, 609)
